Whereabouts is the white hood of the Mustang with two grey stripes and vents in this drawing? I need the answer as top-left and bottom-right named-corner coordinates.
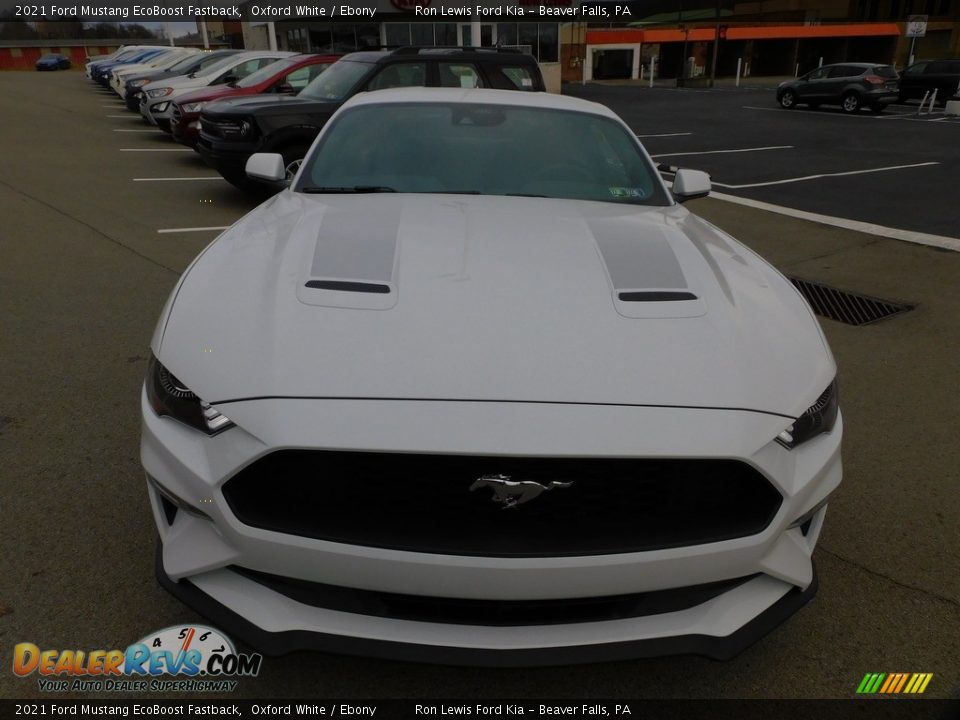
top-left (153, 191), bottom-right (835, 417)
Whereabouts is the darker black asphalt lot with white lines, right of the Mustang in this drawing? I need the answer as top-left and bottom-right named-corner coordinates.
top-left (564, 84), bottom-right (960, 243)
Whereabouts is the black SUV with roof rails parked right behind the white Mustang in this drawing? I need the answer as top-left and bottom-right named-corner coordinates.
top-left (196, 47), bottom-right (546, 191)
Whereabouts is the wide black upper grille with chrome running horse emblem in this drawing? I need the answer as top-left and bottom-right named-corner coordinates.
top-left (223, 450), bottom-right (782, 557)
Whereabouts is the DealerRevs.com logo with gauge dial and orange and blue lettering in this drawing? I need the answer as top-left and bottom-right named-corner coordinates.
top-left (13, 625), bottom-right (263, 692)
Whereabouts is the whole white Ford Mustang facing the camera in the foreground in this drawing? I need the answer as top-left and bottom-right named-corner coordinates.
top-left (142, 89), bottom-right (842, 665)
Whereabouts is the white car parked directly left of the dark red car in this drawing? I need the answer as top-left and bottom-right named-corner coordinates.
top-left (140, 50), bottom-right (296, 132)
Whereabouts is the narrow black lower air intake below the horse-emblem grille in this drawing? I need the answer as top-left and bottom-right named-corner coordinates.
top-left (230, 566), bottom-right (757, 627)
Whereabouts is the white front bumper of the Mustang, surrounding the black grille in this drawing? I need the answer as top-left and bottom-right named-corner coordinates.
top-left (141, 390), bottom-right (842, 665)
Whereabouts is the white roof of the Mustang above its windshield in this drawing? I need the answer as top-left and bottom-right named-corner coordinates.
top-left (343, 87), bottom-right (619, 120)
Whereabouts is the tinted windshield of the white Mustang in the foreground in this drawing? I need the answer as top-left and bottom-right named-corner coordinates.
top-left (296, 100), bottom-right (670, 205)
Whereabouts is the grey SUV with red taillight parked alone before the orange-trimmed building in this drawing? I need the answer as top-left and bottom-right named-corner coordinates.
top-left (777, 63), bottom-right (898, 113)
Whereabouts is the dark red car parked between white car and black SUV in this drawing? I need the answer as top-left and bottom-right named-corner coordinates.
top-left (170, 54), bottom-right (340, 147)
